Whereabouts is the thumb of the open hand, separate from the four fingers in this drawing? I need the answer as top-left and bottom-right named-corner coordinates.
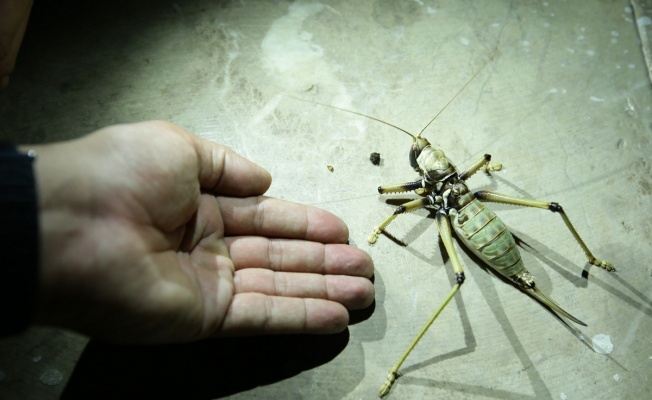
top-left (191, 130), bottom-right (272, 197)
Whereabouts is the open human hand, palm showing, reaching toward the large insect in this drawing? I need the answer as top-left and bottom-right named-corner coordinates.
top-left (28, 122), bottom-right (374, 343)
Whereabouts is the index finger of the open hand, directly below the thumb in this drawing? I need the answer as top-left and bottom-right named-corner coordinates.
top-left (217, 196), bottom-right (349, 243)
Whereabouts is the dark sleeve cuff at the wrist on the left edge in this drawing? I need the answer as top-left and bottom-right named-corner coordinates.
top-left (0, 143), bottom-right (40, 336)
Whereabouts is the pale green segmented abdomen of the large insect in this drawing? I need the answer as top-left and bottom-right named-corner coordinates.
top-left (452, 199), bottom-right (526, 278)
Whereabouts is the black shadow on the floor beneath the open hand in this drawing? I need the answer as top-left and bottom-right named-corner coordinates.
top-left (61, 329), bottom-right (349, 400)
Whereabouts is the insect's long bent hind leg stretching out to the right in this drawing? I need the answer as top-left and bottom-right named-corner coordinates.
top-left (473, 190), bottom-right (616, 271)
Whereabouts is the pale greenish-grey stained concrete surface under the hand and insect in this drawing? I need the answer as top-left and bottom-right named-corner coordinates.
top-left (0, 0), bottom-right (652, 399)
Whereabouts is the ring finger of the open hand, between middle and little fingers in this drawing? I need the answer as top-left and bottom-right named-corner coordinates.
top-left (233, 268), bottom-right (374, 310)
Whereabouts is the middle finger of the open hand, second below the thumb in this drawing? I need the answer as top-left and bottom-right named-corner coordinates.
top-left (226, 236), bottom-right (374, 278)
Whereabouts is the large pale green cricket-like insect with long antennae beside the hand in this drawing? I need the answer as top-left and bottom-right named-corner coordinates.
top-left (302, 44), bottom-right (615, 397)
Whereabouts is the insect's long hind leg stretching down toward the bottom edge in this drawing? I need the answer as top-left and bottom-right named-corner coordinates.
top-left (378, 211), bottom-right (464, 397)
